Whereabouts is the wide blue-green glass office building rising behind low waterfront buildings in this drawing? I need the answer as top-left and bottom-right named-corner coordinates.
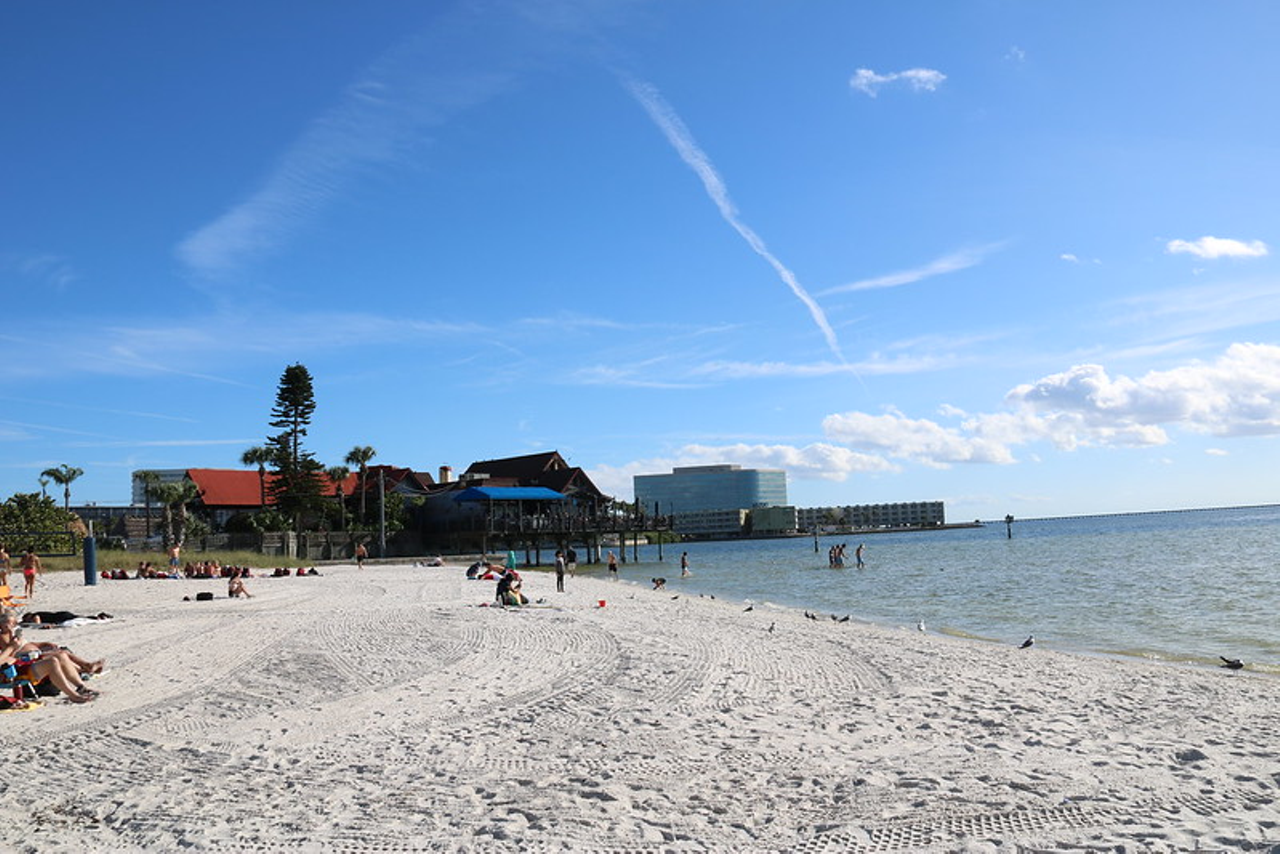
top-left (632, 465), bottom-right (787, 516)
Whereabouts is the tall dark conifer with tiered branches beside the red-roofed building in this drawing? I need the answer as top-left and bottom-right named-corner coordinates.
top-left (266, 365), bottom-right (324, 530)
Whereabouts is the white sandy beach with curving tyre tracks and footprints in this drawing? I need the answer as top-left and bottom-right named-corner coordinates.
top-left (0, 566), bottom-right (1280, 851)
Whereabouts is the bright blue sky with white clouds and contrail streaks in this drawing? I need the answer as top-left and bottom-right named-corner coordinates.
top-left (0, 0), bottom-right (1280, 521)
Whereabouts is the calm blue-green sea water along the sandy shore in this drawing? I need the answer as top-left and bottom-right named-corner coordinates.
top-left (604, 506), bottom-right (1280, 673)
